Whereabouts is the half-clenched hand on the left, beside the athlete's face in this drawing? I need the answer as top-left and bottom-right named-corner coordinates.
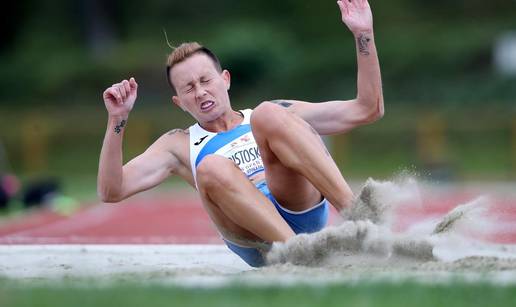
top-left (102, 78), bottom-right (138, 117)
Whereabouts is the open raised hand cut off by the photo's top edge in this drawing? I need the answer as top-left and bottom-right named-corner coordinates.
top-left (337, 0), bottom-right (373, 34)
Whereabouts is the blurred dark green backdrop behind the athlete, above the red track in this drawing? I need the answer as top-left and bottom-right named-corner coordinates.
top-left (0, 0), bottom-right (516, 212)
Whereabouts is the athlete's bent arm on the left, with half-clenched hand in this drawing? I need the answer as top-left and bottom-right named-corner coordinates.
top-left (97, 78), bottom-right (180, 202)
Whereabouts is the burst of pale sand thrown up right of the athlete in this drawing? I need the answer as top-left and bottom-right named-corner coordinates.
top-left (267, 176), bottom-right (516, 266)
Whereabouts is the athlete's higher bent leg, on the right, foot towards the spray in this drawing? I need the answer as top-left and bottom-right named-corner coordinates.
top-left (251, 102), bottom-right (353, 211)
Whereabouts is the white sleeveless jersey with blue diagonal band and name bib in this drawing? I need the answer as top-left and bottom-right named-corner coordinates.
top-left (189, 109), bottom-right (264, 185)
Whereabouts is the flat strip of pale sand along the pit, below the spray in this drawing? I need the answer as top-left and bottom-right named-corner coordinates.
top-left (0, 245), bottom-right (516, 287)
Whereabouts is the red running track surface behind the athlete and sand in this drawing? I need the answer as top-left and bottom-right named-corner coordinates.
top-left (0, 193), bottom-right (516, 244)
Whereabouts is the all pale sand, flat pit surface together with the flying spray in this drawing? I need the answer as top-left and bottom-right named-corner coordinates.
top-left (0, 179), bottom-right (516, 286)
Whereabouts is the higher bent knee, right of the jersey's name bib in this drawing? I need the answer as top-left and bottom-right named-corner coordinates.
top-left (251, 101), bottom-right (290, 133)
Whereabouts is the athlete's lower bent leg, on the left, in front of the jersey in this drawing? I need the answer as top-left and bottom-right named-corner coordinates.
top-left (197, 155), bottom-right (295, 242)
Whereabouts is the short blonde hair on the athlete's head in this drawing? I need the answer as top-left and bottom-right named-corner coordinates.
top-left (167, 42), bottom-right (222, 94)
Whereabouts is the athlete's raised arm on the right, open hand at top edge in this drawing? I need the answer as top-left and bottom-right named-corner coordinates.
top-left (272, 0), bottom-right (384, 135)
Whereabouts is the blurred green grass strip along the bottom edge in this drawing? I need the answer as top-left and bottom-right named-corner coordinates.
top-left (0, 282), bottom-right (516, 307)
